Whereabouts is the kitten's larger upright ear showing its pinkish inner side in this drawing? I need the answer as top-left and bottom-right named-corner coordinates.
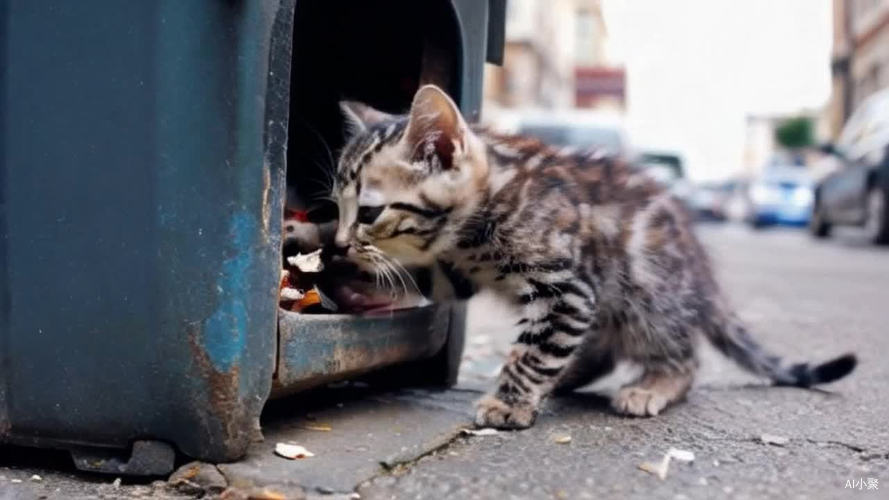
top-left (405, 85), bottom-right (468, 169)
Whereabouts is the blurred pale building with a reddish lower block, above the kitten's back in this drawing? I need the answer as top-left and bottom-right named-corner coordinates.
top-left (485, 0), bottom-right (625, 109)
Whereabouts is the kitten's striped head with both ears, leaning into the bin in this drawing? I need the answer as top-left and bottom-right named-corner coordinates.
top-left (333, 85), bottom-right (487, 265)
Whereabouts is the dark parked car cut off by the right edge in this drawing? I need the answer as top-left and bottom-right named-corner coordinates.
top-left (810, 89), bottom-right (889, 245)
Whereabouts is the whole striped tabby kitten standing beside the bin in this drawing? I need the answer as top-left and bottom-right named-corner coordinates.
top-left (334, 86), bottom-right (856, 428)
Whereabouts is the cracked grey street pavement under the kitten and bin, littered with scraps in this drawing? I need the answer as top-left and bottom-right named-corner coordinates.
top-left (0, 225), bottom-right (889, 500)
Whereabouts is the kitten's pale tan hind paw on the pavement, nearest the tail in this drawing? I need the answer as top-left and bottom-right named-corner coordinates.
top-left (611, 364), bottom-right (694, 417)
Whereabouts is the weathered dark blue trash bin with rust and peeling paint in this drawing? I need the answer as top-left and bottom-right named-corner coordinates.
top-left (0, 0), bottom-right (503, 474)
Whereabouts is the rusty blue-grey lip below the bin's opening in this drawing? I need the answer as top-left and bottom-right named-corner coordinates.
top-left (273, 304), bottom-right (450, 396)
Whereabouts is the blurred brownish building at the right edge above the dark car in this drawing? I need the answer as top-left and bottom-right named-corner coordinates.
top-left (827, 0), bottom-right (889, 139)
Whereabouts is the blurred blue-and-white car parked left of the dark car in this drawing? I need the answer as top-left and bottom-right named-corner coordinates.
top-left (747, 163), bottom-right (813, 229)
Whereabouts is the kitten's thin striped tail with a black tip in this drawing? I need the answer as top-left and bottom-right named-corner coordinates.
top-left (707, 321), bottom-right (858, 387)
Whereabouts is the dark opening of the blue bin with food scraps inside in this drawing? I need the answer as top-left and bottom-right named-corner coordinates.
top-left (281, 0), bottom-right (461, 313)
